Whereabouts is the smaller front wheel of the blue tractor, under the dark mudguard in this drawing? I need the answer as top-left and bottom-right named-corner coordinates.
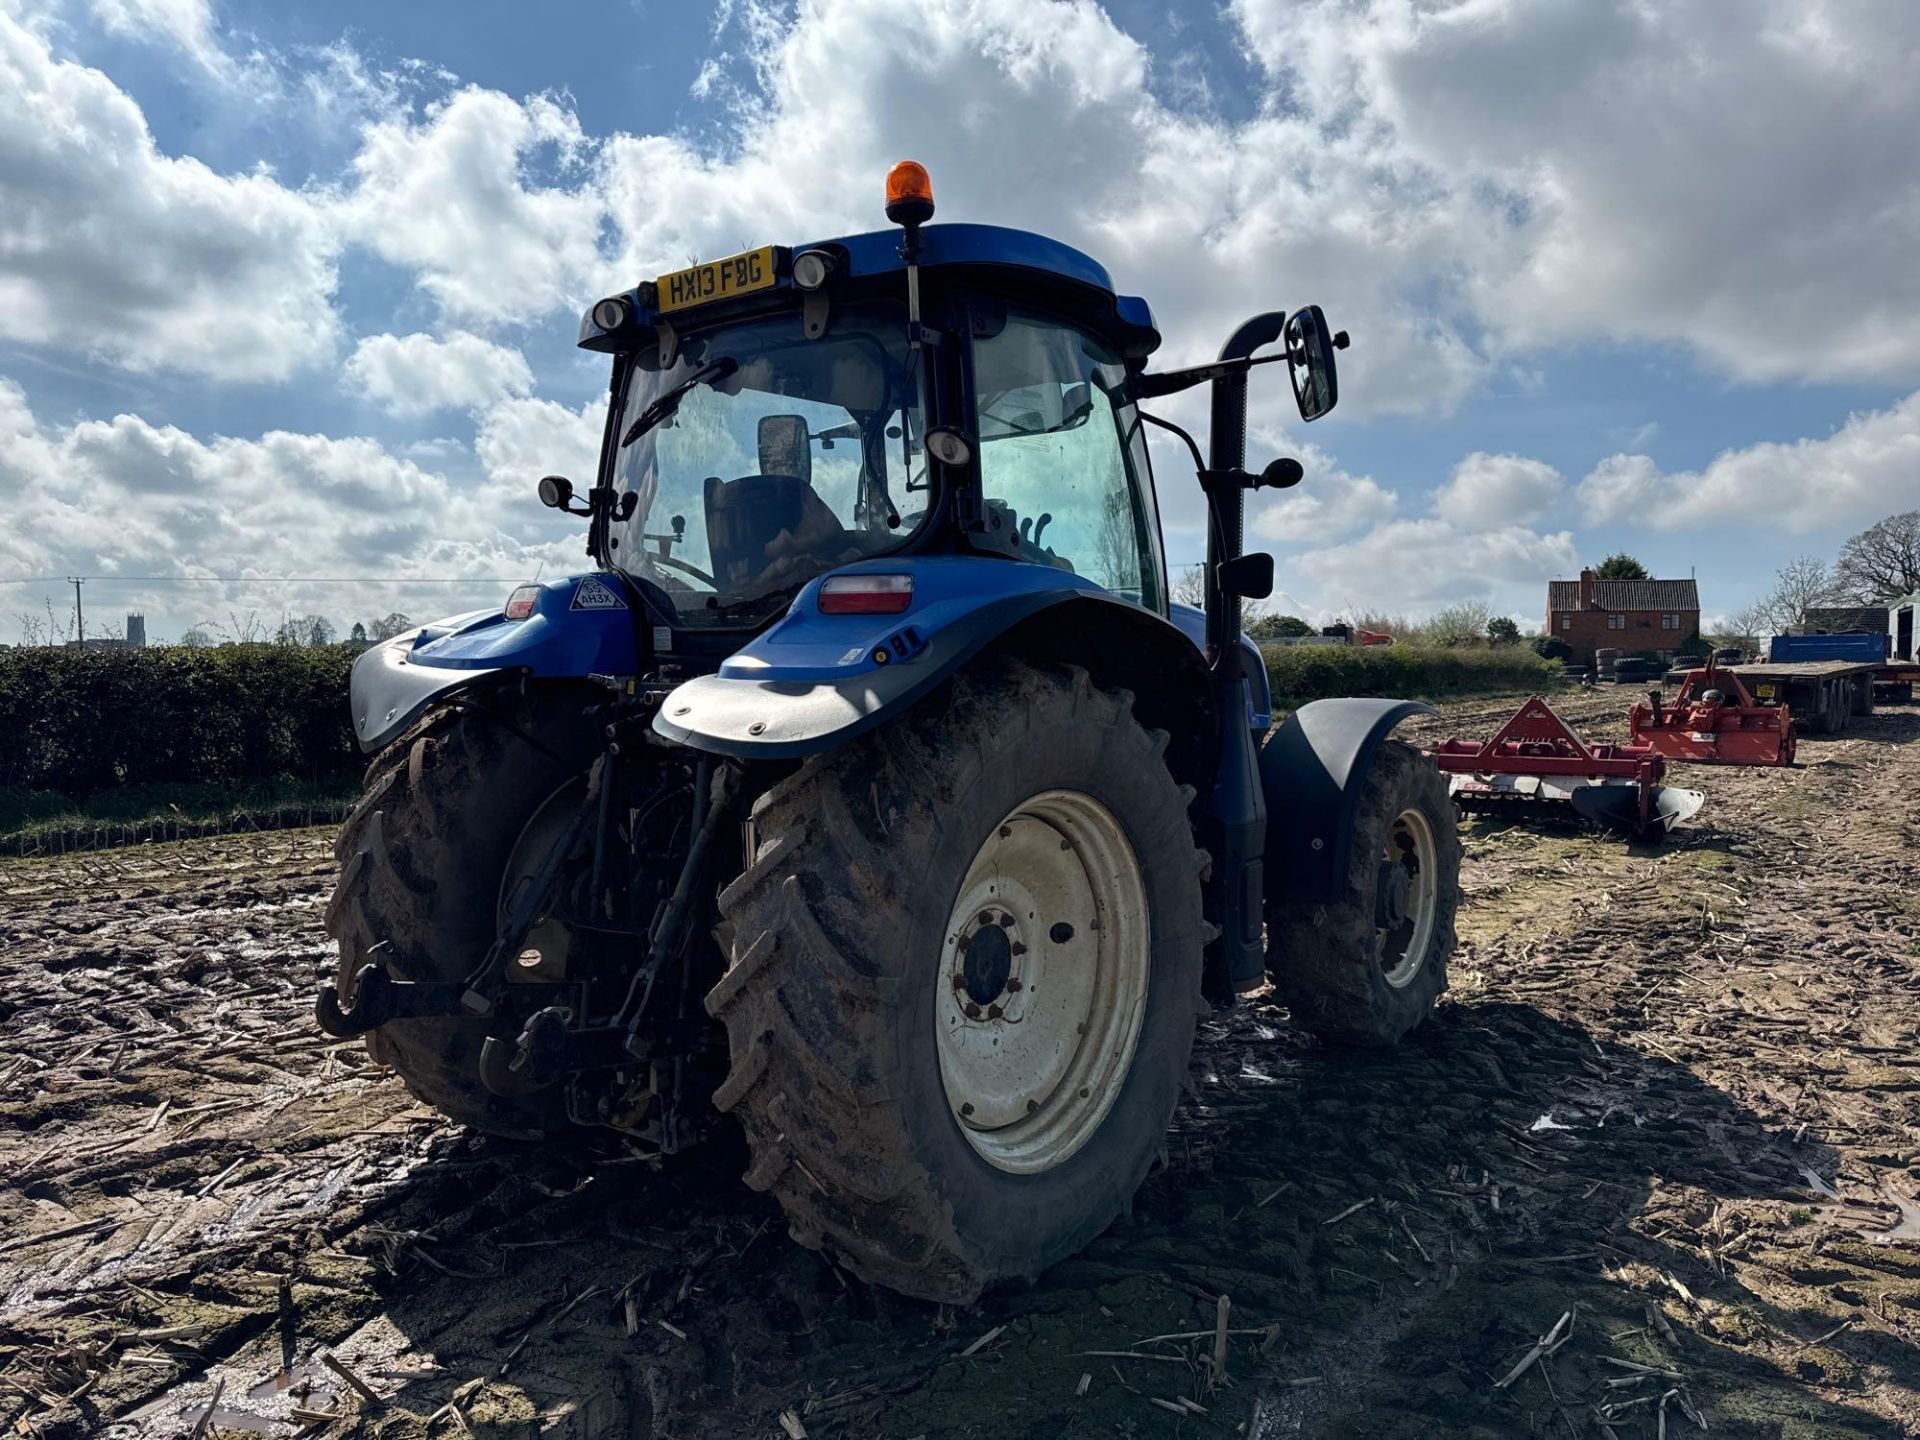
top-left (1267, 739), bottom-right (1459, 1046)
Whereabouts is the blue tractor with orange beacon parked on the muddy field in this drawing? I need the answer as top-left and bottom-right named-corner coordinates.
top-left (319, 161), bottom-right (1459, 1302)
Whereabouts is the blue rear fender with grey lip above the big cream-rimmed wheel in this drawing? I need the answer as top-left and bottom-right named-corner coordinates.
top-left (653, 555), bottom-right (1200, 760)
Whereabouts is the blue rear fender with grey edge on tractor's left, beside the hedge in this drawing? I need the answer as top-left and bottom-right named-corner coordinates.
top-left (351, 574), bottom-right (639, 751)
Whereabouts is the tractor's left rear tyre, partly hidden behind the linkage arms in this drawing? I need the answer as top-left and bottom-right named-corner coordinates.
top-left (326, 693), bottom-right (597, 1139)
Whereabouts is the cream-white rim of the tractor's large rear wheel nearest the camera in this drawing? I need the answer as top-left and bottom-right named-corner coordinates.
top-left (933, 789), bottom-right (1152, 1175)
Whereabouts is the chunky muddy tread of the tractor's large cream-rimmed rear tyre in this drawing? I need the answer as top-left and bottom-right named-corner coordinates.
top-left (707, 662), bottom-right (1206, 1304)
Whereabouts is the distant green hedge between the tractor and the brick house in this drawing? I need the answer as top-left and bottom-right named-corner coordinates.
top-left (1261, 645), bottom-right (1561, 705)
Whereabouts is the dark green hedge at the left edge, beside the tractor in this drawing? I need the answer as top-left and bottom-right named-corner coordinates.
top-left (0, 645), bottom-right (363, 799)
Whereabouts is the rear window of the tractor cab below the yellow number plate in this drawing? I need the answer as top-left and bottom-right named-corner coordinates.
top-left (611, 303), bottom-right (929, 626)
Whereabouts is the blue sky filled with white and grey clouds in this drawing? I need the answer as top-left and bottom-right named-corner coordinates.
top-left (0, 0), bottom-right (1920, 641)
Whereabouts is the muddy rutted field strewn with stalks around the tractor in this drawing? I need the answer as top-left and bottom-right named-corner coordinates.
top-left (0, 691), bottom-right (1920, 1440)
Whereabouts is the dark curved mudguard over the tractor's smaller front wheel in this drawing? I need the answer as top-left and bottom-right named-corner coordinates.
top-left (1260, 699), bottom-right (1438, 904)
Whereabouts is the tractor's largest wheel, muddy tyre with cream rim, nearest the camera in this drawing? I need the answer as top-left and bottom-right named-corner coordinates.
top-left (707, 662), bottom-right (1204, 1304)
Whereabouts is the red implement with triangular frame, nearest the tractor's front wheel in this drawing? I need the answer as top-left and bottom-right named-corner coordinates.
top-left (1432, 695), bottom-right (1707, 835)
